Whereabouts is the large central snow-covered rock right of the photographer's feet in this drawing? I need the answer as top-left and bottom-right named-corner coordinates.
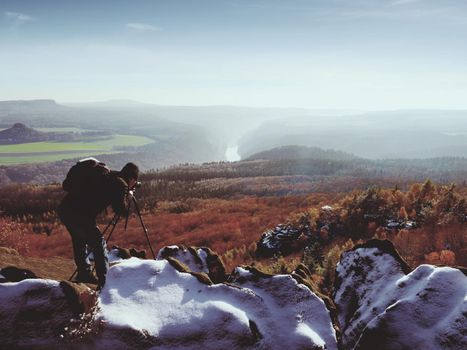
top-left (91, 258), bottom-right (337, 349)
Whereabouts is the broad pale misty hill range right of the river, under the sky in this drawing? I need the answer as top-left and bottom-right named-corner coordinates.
top-left (238, 110), bottom-right (467, 159)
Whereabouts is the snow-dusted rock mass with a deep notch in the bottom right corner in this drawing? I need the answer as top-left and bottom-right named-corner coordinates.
top-left (334, 240), bottom-right (467, 350)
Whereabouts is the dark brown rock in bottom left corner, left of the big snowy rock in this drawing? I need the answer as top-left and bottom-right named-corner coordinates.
top-left (0, 279), bottom-right (93, 349)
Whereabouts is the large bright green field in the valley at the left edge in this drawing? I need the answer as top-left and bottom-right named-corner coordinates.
top-left (0, 135), bottom-right (154, 165)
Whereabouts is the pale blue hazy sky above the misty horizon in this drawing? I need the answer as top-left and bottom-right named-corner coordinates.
top-left (0, 0), bottom-right (467, 109)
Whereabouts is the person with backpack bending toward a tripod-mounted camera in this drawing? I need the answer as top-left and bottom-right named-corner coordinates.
top-left (58, 158), bottom-right (139, 289)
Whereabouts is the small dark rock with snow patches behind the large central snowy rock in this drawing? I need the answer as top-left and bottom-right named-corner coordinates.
top-left (157, 245), bottom-right (227, 283)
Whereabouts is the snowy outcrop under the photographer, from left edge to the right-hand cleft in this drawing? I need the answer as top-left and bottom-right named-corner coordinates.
top-left (0, 246), bottom-right (337, 350)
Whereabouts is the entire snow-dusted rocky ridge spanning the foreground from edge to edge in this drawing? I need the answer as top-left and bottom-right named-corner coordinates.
top-left (0, 240), bottom-right (467, 349)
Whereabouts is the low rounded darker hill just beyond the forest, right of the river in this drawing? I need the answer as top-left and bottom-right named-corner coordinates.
top-left (246, 145), bottom-right (357, 160)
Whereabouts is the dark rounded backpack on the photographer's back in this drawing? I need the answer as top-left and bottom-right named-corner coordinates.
top-left (62, 157), bottom-right (110, 194)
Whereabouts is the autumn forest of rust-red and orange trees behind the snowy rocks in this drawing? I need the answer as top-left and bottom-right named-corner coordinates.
top-left (0, 152), bottom-right (467, 293)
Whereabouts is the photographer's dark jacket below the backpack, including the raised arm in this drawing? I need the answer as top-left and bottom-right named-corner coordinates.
top-left (58, 171), bottom-right (128, 224)
